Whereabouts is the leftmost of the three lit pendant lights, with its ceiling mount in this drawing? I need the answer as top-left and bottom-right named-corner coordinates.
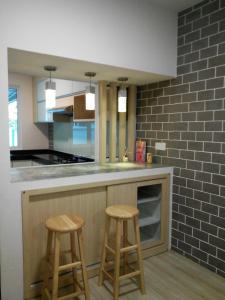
top-left (44, 66), bottom-right (57, 109)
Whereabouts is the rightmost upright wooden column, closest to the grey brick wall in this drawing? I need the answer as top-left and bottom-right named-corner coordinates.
top-left (127, 85), bottom-right (137, 161)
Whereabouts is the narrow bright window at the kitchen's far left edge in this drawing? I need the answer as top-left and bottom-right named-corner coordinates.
top-left (8, 87), bottom-right (19, 148)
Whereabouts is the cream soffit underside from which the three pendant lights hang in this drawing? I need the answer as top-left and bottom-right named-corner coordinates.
top-left (8, 49), bottom-right (171, 85)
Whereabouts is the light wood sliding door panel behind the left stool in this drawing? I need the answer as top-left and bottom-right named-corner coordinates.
top-left (22, 187), bottom-right (106, 299)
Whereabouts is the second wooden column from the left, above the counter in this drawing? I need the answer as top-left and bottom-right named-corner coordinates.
top-left (109, 83), bottom-right (117, 162)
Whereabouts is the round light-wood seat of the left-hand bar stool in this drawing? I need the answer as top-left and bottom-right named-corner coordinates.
top-left (46, 215), bottom-right (84, 233)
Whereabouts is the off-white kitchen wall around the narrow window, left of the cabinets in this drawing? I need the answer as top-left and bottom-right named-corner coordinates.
top-left (9, 73), bottom-right (49, 150)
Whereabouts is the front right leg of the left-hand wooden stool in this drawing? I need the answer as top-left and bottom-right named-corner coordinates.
top-left (77, 228), bottom-right (90, 300)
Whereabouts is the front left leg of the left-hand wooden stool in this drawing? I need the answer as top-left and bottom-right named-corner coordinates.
top-left (52, 233), bottom-right (60, 300)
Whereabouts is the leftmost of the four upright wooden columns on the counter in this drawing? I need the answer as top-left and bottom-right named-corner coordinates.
top-left (99, 81), bottom-right (107, 162)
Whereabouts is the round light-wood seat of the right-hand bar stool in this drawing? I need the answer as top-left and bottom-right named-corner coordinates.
top-left (105, 205), bottom-right (139, 219)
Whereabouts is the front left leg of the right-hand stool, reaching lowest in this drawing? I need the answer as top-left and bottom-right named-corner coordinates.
top-left (113, 220), bottom-right (122, 300)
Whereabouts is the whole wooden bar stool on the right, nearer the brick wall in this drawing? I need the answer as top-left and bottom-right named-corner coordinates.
top-left (99, 205), bottom-right (145, 300)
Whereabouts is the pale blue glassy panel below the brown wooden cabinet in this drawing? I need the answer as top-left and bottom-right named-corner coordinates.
top-left (73, 122), bottom-right (95, 145)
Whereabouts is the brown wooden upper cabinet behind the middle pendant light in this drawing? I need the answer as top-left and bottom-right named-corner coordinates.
top-left (73, 95), bottom-right (95, 121)
